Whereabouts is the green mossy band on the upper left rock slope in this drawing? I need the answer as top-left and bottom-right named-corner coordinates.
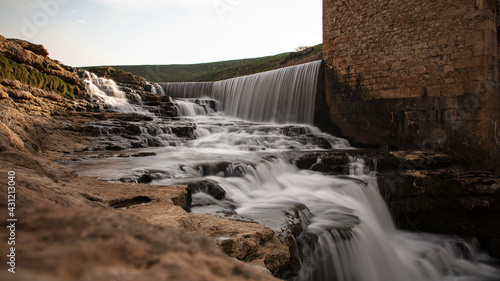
top-left (0, 55), bottom-right (80, 99)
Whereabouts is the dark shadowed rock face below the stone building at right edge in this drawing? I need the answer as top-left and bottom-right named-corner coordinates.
top-left (379, 153), bottom-right (500, 255)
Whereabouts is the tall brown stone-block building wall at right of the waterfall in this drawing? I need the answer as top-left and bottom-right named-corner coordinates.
top-left (323, 0), bottom-right (500, 165)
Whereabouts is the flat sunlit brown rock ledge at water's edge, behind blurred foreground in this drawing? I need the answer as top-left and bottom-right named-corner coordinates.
top-left (76, 178), bottom-right (290, 274)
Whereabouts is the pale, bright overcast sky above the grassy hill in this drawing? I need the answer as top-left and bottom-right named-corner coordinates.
top-left (0, 0), bottom-right (322, 67)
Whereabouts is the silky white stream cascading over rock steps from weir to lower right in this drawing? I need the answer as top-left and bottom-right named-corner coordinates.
top-left (67, 64), bottom-right (500, 281)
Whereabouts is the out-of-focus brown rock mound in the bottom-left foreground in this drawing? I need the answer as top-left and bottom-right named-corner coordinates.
top-left (0, 203), bottom-right (276, 281)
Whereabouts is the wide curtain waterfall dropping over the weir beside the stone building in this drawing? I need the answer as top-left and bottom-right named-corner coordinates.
top-left (161, 61), bottom-right (321, 124)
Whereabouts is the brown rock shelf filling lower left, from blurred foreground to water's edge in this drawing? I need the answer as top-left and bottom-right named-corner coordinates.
top-left (0, 153), bottom-right (290, 280)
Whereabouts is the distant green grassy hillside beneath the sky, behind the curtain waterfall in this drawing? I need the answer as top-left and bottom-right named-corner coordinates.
top-left (96, 44), bottom-right (323, 82)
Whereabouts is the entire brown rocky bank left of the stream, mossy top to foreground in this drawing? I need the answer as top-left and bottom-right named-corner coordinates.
top-left (0, 37), bottom-right (290, 280)
